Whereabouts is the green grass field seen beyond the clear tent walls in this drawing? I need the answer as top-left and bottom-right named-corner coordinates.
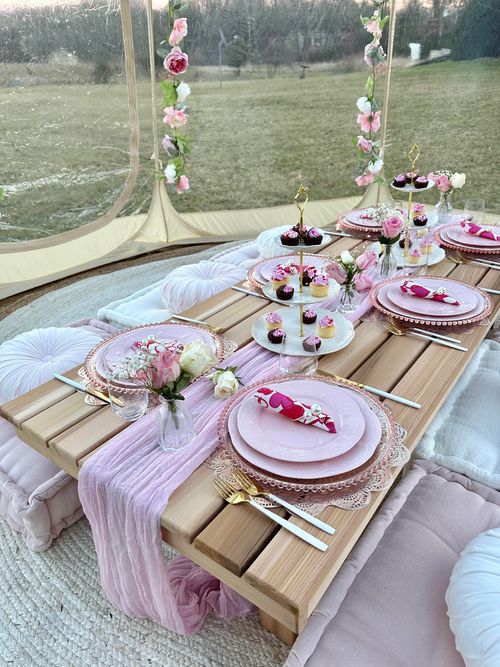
top-left (0, 60), bottom-right (500, 241)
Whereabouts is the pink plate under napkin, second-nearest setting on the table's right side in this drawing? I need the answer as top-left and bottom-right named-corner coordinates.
top-left (387, 278), bottom-right (480, 317)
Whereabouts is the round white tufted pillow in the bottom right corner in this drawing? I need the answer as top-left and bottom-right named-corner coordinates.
top-left (446, 528), bottom-right (500, 667)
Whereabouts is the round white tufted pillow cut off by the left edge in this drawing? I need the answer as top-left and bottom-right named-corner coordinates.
top-left (0, 327), bottom-right (102, 404)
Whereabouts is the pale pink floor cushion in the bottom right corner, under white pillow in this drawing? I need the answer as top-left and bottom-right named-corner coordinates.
top-left (285, 461), bottom-right (500, 667)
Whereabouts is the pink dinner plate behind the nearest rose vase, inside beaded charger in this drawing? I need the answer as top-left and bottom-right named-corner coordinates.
top-left (95, 324), bottom-right (217, 377)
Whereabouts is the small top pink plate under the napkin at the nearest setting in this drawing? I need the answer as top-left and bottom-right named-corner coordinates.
top-left (237, 380), bottom-right (365, 463)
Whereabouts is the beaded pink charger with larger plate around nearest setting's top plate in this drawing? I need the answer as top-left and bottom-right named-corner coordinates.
top-left (218, 376), bottom-right (394, 494)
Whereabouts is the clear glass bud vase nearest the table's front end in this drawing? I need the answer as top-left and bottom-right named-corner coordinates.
top-left (156, 396), bottom-right (196, 452)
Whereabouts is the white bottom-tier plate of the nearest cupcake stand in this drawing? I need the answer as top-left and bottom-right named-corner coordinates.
top-left (252, 308), bottom-right (355, 357)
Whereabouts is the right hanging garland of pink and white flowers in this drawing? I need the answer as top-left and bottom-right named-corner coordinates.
top-left (353, 0), bottom-right (389, 187)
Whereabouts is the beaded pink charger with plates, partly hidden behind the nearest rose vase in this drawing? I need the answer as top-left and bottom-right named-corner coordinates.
top-left (83, 322), bottom-right (225, 387)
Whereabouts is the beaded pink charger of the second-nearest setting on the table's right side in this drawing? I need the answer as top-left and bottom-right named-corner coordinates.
top-left (370, 278), bottom-right (493, 326)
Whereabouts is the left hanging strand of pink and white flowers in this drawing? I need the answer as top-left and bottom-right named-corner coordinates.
top-left (157, 0), bottom-right (191, 195)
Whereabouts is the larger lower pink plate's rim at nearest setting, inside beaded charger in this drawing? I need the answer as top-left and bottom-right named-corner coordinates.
top-left (227, 395), bottom-right (382, 479)
